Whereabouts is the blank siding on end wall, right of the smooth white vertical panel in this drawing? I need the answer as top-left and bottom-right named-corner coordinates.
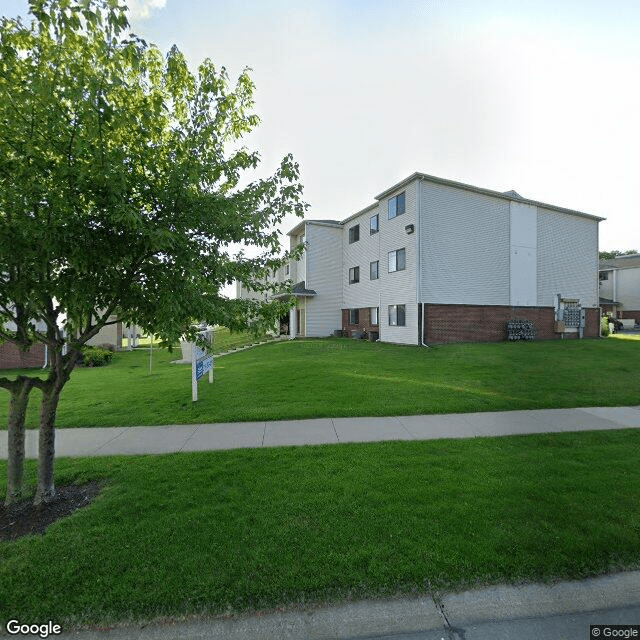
top-left (537, 207), bottom-right (599, 307)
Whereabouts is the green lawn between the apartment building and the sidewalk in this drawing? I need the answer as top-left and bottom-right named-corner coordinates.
top-left (0, 334), bottom-right (640, 428)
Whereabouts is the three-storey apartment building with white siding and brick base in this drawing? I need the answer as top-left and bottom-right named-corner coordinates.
top-left (239, 173), bottom-right (602, 344)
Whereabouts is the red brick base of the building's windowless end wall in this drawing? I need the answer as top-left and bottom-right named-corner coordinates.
top-left (424, 304), bottom-right (600, 344)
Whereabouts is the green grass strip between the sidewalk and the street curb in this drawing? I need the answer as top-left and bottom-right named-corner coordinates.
top-left (0, 430), bottom-right (640, 627)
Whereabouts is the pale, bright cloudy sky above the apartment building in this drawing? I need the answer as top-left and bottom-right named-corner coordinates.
top-left (0, 0), bottom-right (640, 270)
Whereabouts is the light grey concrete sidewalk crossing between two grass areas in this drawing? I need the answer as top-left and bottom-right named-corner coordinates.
top-left (0, 406), bottom-right (640, 458)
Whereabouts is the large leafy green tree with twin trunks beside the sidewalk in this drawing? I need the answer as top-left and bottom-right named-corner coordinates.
top-left (0, 0), bottom-right (306, 503)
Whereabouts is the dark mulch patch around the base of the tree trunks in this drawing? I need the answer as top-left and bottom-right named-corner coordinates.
top-left (0, 481), bottom-right (103, 542)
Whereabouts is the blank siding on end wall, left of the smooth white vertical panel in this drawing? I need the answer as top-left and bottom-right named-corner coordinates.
top-left (419, 181), bottom-right (510, 305)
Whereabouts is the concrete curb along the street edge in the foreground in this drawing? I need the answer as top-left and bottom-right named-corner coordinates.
top-left (57, 571), bottom-right (640, 640)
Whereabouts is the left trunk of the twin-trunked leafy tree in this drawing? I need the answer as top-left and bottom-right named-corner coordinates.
top-left (5, 378), bottom-right (33, 505)
